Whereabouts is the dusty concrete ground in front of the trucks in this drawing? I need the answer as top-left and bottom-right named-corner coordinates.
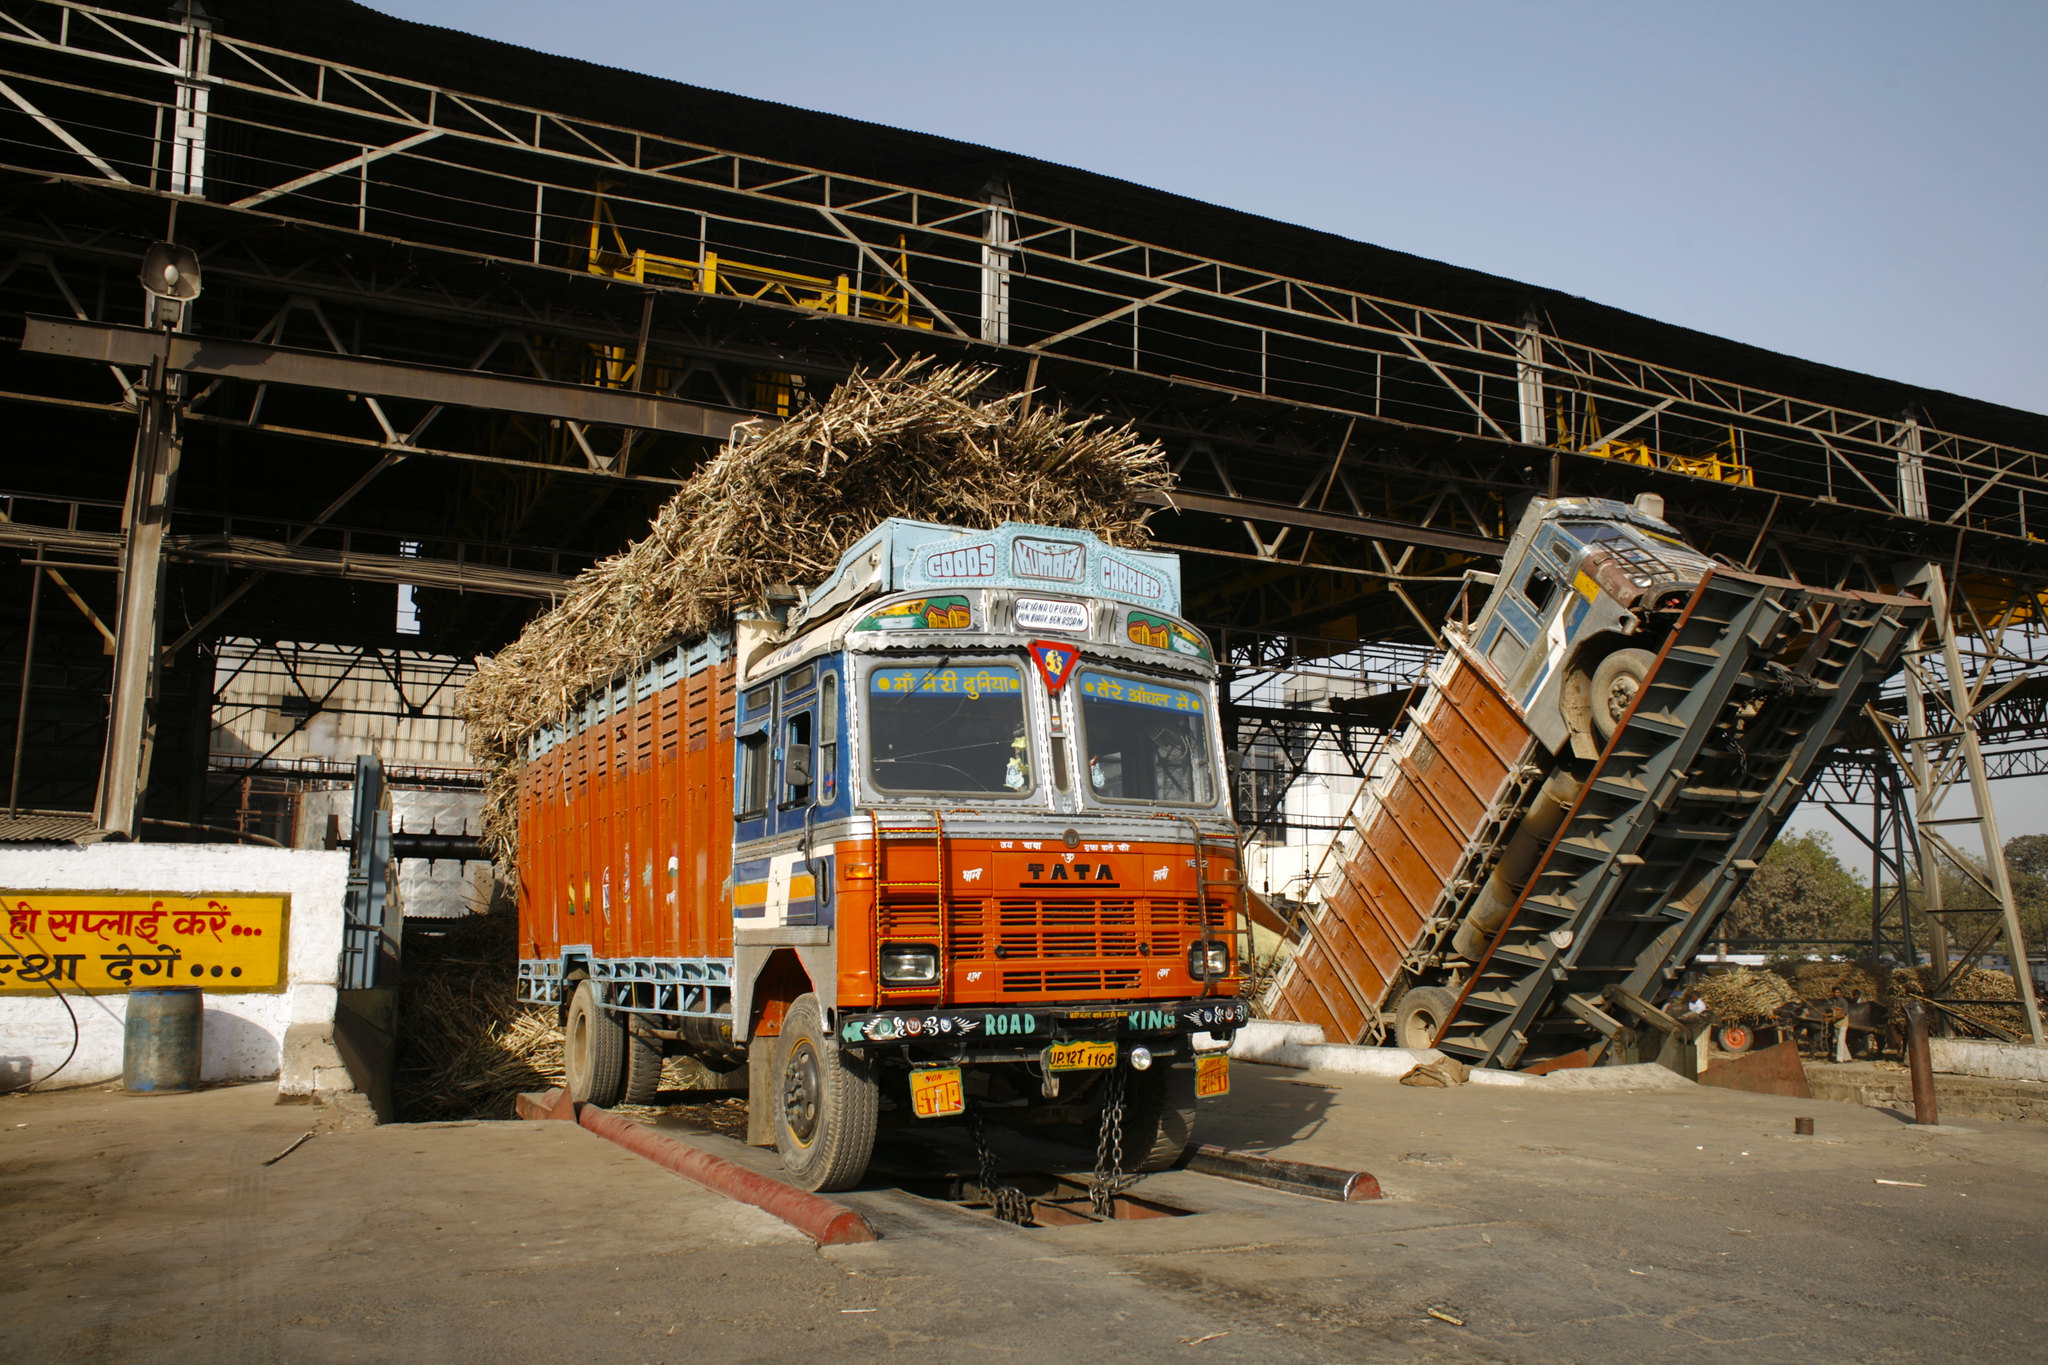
top-left (0, 1064), bottom-right (2048, 1365)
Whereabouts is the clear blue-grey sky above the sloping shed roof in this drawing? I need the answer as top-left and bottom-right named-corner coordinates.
top-left (373, 0), bottom-right (2048, 847)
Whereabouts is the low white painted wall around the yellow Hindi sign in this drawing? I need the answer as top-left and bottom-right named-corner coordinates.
top-left (0, 843), bottom-right (348, 1093)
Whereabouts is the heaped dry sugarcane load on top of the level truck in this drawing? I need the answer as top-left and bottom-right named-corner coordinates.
top-left (461, 358), bottom-right (1171, 866)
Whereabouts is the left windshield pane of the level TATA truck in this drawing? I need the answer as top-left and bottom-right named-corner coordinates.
top-left (868, 661), bottom-right (1032, 796)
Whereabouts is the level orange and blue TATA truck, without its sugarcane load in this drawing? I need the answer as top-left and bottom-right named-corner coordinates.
top-left (518, 518), bottom-right (1247, 1189)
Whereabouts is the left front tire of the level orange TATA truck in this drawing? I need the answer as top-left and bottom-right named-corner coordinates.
top-left (770, 995), bottom-right (879, 1189)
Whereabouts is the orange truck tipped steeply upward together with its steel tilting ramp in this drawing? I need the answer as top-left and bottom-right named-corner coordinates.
top-left (1266, 497), bottom-right (1929, 1068)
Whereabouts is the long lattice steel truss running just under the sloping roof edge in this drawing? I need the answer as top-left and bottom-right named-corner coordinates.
top-left (0, 0), bottom-right (2048, 536)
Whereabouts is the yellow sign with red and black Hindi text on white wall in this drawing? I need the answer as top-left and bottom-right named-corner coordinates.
top-left (0, 890), bottom-right (291, 995)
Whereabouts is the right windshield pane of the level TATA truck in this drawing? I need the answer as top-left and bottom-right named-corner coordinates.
top-left (1079, 673), bottom-right (1217, 806)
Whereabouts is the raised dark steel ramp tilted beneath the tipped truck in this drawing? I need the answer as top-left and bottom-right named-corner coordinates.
top-left (1438, 569), bottom-right (1929, 1068)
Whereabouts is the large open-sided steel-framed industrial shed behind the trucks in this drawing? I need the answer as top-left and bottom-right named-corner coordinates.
top-left (0, 0), bottom-right (2048, 1023)
